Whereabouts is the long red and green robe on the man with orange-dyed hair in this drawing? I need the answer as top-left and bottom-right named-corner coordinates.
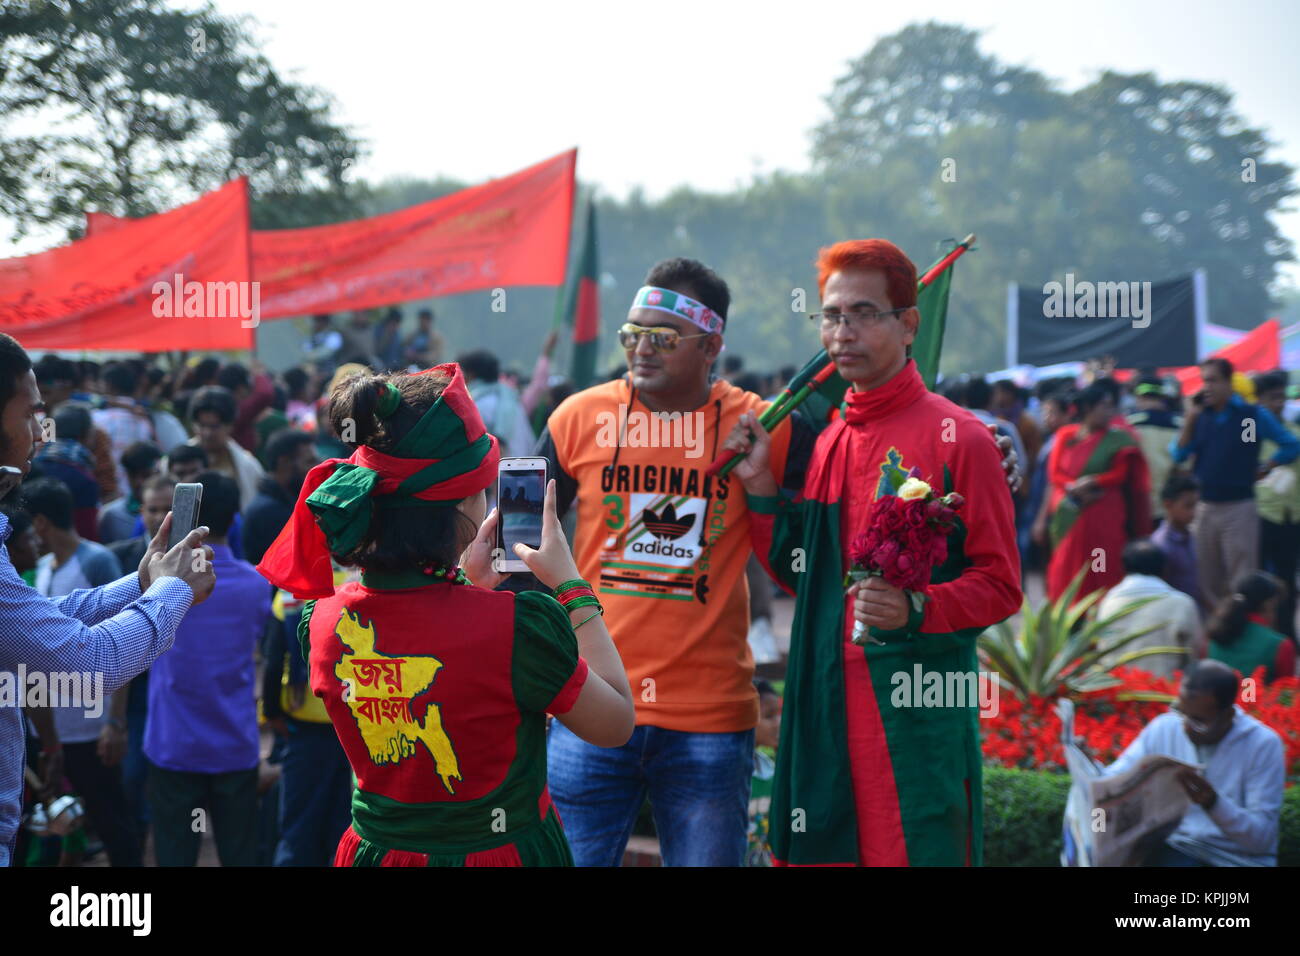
top-left (749, 360), bottom-right (1021, 866)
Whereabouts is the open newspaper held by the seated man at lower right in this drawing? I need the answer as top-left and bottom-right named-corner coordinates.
top-left (1057, 700), bottom-right (1204, 866)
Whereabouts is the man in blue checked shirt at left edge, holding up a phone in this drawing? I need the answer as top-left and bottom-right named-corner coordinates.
top-left (0, 333), bottom-right (216, 866)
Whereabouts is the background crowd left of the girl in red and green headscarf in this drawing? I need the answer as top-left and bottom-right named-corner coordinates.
top-left (3, 310), bottom-right (624, 865)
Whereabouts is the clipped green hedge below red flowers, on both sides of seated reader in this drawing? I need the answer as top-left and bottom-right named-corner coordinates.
top-left (984, 766), bottom-right (1300, 866)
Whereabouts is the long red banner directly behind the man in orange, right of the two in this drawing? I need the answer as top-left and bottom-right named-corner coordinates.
top-left (86, 150), bottom-right (577, 319)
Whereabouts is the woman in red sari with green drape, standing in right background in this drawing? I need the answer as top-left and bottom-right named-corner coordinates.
top-left (1048, 381), bottom-right (1151, 601)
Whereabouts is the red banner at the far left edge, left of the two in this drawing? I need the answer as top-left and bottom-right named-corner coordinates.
top-left (0, 178), bottom-right (260, 351)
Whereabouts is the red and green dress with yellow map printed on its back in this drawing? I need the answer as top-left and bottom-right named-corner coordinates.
top-left (299, 572), bottom-right (588, 866)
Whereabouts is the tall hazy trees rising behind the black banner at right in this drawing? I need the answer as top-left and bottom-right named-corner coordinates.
top-left (813, 23), bottom-right (1296, 372)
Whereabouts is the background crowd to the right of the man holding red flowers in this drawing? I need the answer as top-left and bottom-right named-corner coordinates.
top-left (944, 358), bottom-right (1300, 680)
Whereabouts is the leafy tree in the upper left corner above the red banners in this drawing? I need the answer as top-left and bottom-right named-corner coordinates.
top-left (0, 0), bottom-right (359, 235)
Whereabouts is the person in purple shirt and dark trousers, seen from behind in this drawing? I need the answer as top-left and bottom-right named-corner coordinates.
top-left (144, 471), bottom-right (270, 866)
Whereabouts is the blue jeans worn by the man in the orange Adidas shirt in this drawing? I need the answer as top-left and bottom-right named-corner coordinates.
top-left (546, 721), bottom-right (754, 866)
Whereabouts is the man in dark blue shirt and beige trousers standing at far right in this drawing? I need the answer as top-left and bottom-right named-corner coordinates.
top-left (1169, 358), bottom-right (1300, 607)
